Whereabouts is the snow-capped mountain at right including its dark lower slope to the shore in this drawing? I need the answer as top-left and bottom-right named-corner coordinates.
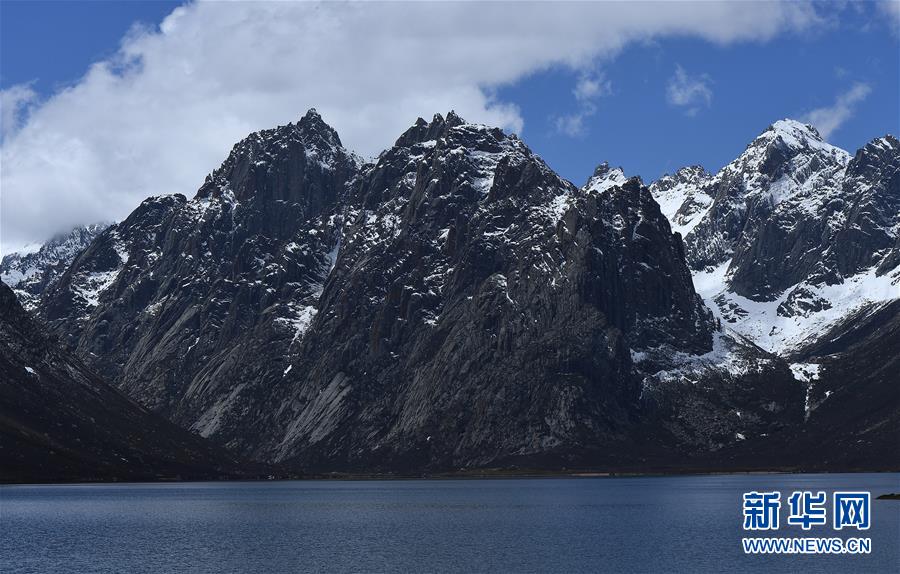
top-left (650, 120), bottom-right (900, 468)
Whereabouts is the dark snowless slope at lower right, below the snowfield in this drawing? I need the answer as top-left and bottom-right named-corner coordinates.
top-left (724, 299), bottom-right (900, 472)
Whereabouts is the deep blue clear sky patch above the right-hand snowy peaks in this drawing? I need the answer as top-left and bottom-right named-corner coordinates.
top-left (501, 24), bottom-right (900, 183)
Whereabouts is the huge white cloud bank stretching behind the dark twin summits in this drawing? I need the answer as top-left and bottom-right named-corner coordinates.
top-left (0, 2), bottom-right (821, 252)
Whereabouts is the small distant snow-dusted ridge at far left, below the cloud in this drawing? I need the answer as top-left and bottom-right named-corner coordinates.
top-left (0, 223), bottom-right (110, 309)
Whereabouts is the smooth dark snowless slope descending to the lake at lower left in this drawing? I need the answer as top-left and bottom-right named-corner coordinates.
top-left (0, 283), bottom-right (246, 482)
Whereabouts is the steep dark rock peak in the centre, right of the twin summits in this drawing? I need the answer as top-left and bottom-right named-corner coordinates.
top-left (262, 122), bottom-right (712, 468)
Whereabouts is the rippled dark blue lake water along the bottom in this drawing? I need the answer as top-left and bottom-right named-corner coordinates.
top-left (0, 474), bottom-right (900, 573)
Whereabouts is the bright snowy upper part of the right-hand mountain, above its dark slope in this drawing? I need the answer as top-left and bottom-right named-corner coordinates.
top-left (650, 120), bottom-right (900, 356)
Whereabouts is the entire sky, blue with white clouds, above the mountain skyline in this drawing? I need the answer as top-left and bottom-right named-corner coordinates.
top-left (0, 0), bottom-right (900, 250)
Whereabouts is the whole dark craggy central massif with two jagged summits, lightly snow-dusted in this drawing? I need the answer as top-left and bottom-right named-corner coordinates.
top-left (41, 112), bottom-right (802, 470)
